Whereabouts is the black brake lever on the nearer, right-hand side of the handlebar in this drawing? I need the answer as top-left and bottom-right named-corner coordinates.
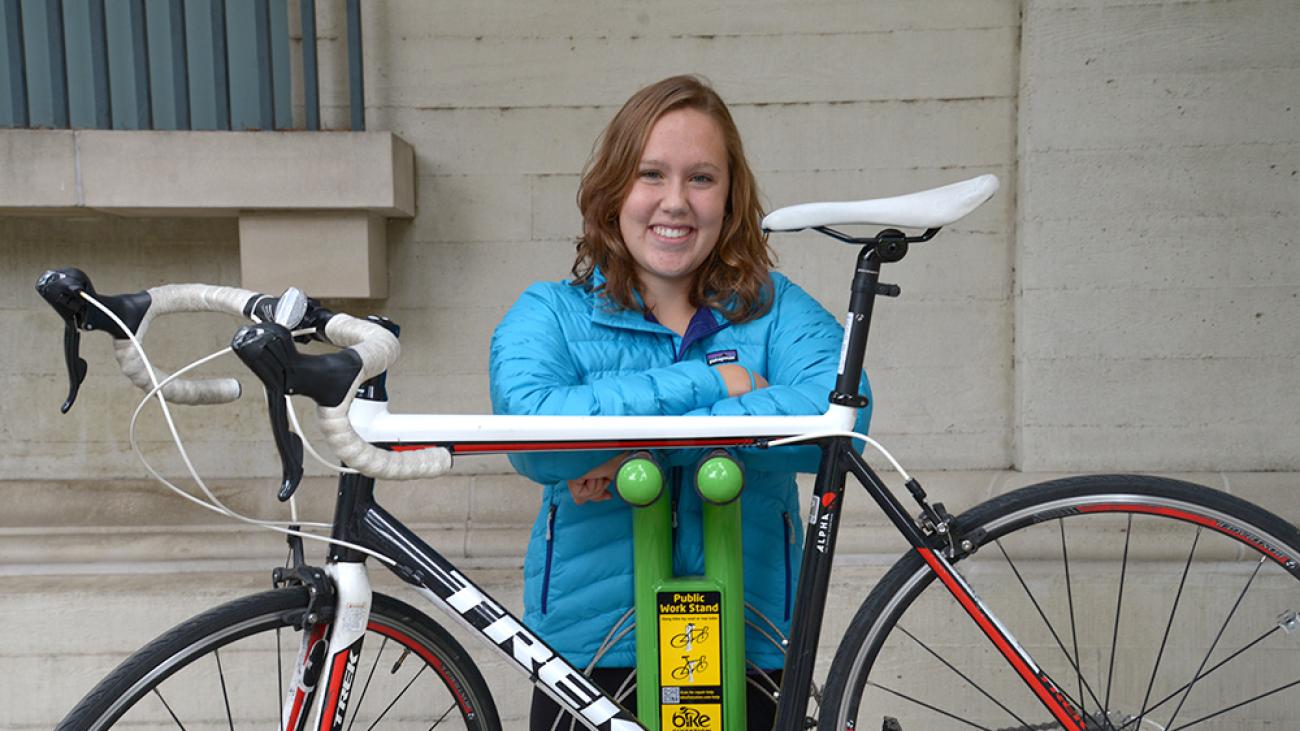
top-left (230, 323), bottom-right (303, 502)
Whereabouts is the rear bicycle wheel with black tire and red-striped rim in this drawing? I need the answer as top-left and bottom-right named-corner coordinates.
top-left (819, 475), bottom-right (1300, 731)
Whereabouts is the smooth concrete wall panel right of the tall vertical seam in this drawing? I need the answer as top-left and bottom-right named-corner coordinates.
top-left (1015, 0), bottom-right (1300, 470)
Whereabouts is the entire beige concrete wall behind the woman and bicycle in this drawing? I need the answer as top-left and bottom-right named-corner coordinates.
top-left (0, 0), bottom-right (1300, 728)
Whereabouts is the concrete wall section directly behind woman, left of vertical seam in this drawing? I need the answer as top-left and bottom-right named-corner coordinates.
top-left (367, 0), bottom-right (1019, 468)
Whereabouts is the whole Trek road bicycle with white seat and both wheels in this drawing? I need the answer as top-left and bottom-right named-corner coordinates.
top-left (38, 176), bottom-right (1300, 731)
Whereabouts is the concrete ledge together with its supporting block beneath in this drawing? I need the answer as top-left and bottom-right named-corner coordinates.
top-left (0, 130), bottom-right (415, 298)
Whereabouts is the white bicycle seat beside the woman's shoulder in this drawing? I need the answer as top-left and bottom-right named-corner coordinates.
top-left (763, 176), bottom-right (997, 232)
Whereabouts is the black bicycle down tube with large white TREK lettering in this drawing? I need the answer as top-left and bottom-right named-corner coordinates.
top-left (360, 505), bottom-right (642, 731)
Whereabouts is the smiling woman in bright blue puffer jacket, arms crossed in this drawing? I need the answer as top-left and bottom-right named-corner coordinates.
top-left (490, 77), bottom-right (870, 728)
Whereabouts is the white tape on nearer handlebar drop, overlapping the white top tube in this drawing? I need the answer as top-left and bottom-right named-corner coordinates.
top-left (316, 315), bottom-right (451, 480)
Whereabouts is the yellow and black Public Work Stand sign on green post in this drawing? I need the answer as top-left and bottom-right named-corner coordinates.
top-left (657, 592), bottom-right (723, 731)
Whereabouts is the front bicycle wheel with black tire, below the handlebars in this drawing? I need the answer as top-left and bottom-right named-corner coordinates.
top-left (56, 587), bottom-right (501, 731)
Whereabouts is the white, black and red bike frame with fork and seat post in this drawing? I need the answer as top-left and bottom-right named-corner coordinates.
top-left (283, 229), bottom-right (1084, 731)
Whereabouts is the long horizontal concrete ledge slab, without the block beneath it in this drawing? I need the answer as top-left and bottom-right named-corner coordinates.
top-left (0, 130), bottom-right (415, 219)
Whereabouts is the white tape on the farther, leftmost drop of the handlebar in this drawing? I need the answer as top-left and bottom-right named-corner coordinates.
top-left (113, 285), bottom-right (257, 405)
